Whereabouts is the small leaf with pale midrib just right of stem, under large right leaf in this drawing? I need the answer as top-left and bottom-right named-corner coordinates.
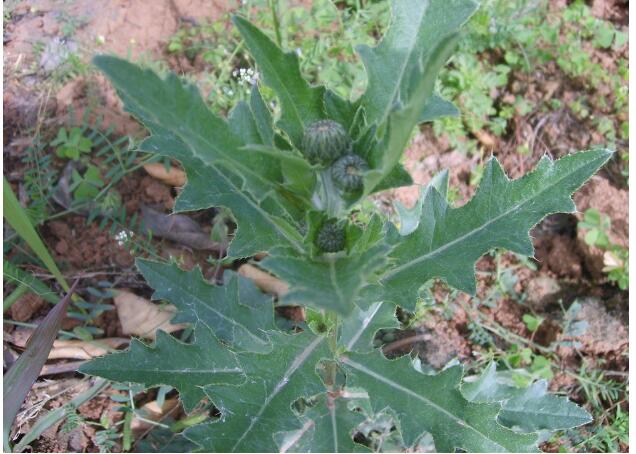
top-left (338, 302), bottom-right (400, 353)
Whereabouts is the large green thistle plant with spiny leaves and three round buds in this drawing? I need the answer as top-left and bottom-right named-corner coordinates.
top-left (81, 0), bottom-right (611, 452)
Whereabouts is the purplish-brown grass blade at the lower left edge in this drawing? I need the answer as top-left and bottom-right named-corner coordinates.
top-left (2, 280), bottom-right (78, 451)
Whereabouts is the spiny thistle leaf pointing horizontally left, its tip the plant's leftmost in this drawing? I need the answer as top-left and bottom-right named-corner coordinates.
top-left (79, 323), bottom-right (245, 411)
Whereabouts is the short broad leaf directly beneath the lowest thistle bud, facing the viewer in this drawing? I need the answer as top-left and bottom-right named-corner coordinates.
top-left (261, 243), bottom-right (388, 315)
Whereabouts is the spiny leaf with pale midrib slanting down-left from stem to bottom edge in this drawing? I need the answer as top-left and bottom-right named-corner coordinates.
top-left (186, 332), bottom-right (329, 452)
